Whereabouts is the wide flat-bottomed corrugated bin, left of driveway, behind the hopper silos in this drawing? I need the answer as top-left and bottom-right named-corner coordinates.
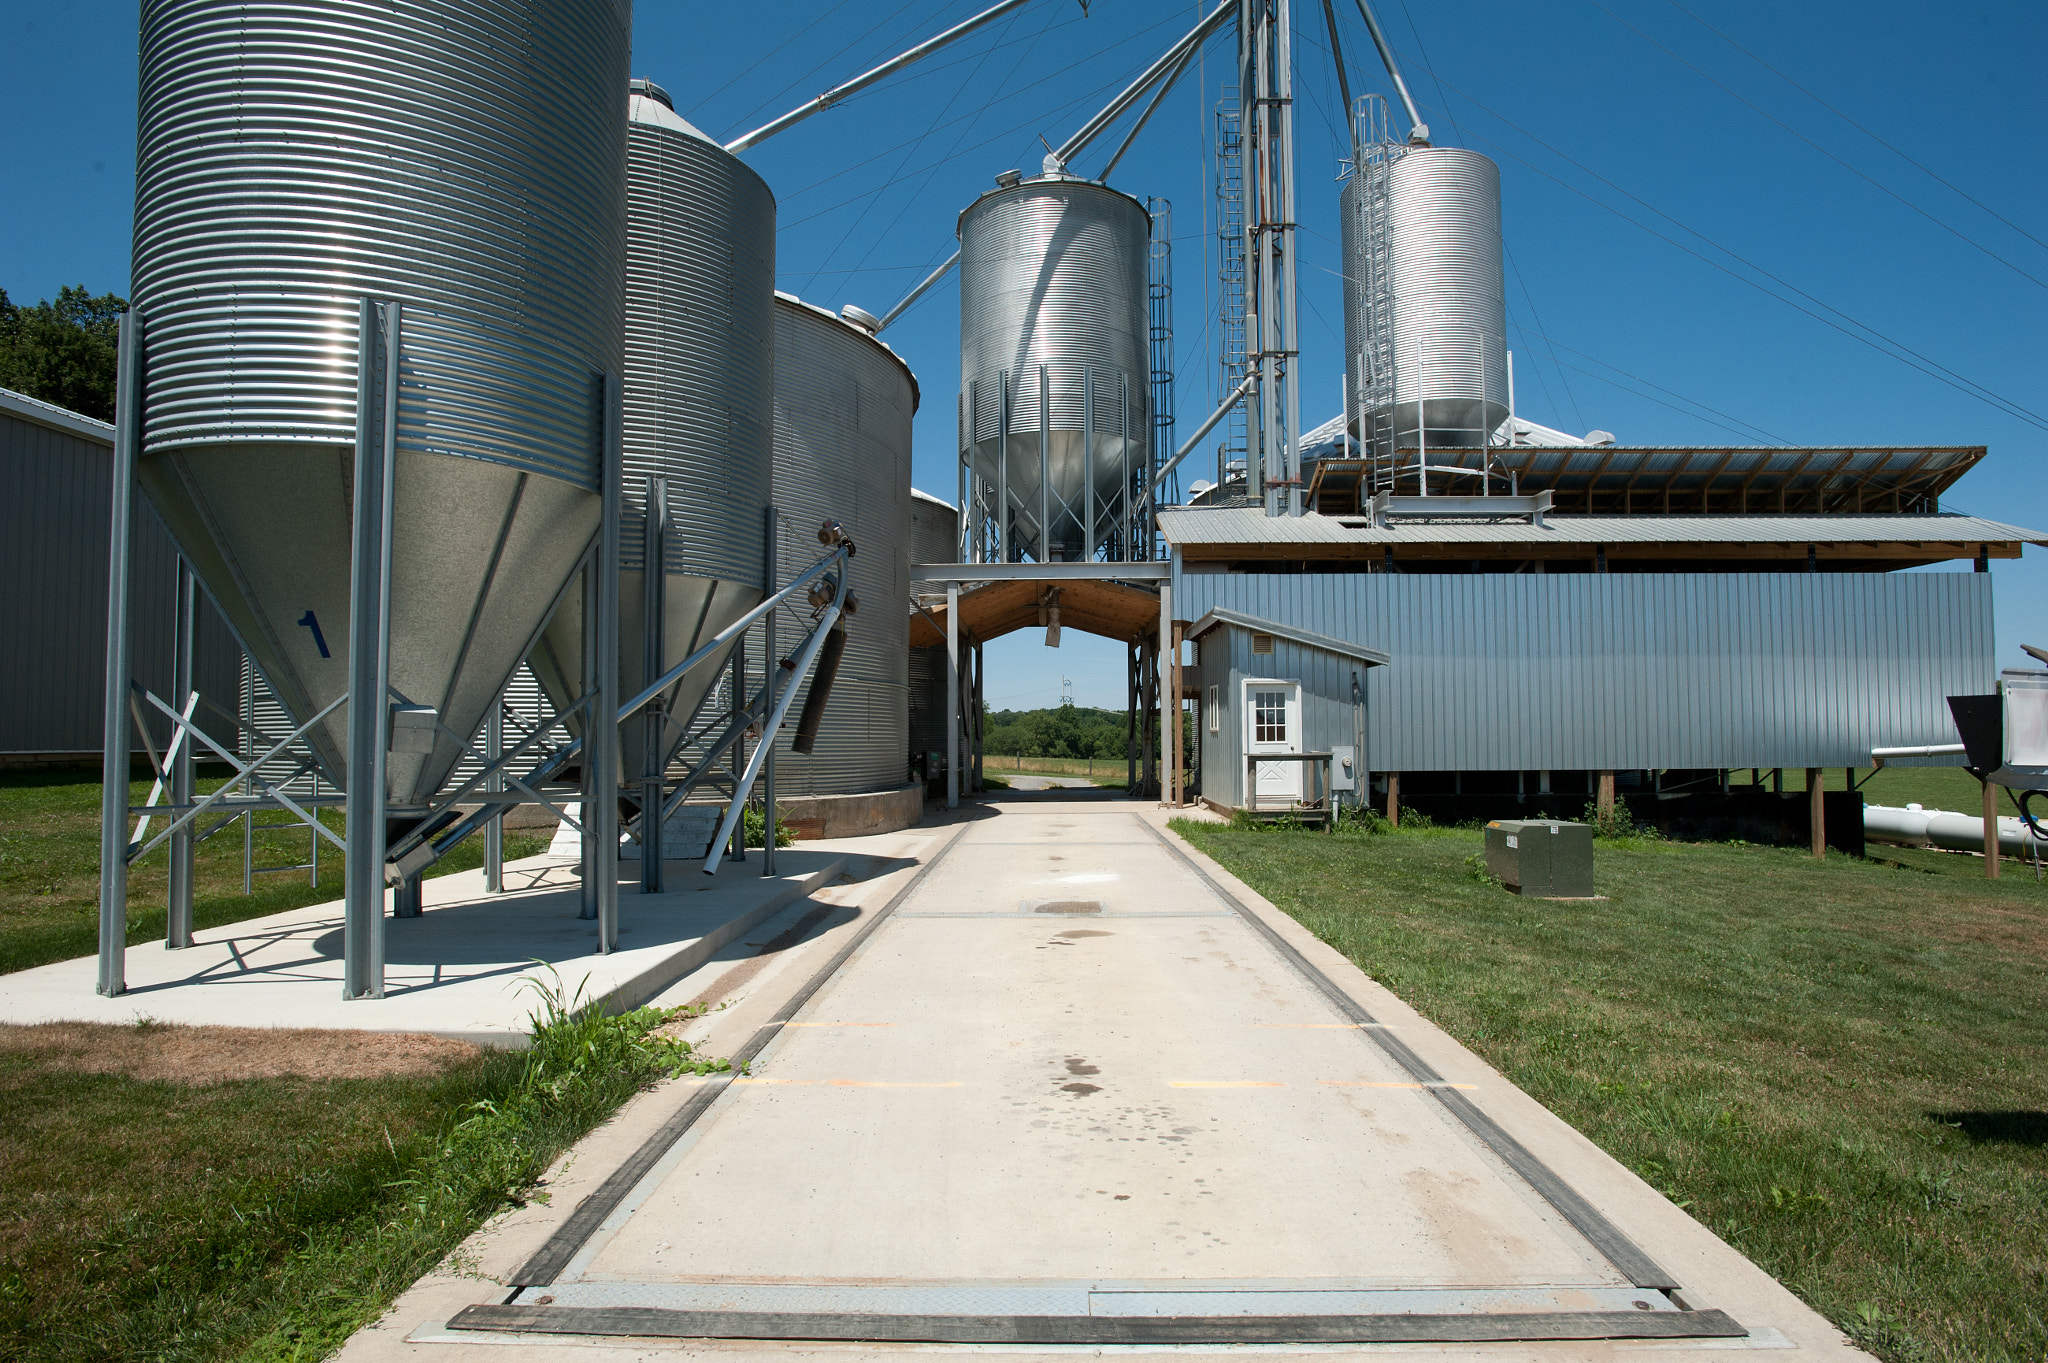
top-left (774, 293), bottom-right (918, 796)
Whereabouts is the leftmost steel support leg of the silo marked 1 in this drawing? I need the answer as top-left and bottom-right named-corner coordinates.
top-left (98, 311), bottom-right (141, 999)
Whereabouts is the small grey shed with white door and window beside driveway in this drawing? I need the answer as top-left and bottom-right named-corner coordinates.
top-left (1182, 608), bottom-right (1389, 808)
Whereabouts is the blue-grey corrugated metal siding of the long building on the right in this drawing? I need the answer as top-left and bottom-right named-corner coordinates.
top-left (1174, 573), bottom-right (1997, 772)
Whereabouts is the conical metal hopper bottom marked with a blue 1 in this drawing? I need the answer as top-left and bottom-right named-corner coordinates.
top-left (139, 442), bottom-right (602, 806)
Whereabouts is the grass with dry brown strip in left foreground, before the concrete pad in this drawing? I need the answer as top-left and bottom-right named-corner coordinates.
top-left (0, 986), bottom-right (723, 1363)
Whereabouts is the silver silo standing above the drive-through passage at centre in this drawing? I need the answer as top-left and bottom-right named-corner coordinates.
top-left (958, 174), bottom-right (1151, 561)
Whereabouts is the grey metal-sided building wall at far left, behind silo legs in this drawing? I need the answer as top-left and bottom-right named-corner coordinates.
top-left (0, 411), bottom-right (242, 753)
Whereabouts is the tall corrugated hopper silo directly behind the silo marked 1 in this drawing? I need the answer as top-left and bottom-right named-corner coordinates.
top-left (532, 80), bottom-right (774, 774)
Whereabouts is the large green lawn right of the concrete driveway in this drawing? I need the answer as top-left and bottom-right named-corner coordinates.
top-left (1176, 818), bottom-right (2048, 1363)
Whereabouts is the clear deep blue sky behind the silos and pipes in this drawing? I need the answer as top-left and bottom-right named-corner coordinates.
top-left (0, 0), bottom-right (2048, 706)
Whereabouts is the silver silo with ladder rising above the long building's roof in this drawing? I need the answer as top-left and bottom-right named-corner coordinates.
top-left (1341, 145), bottom-right (1507, 467)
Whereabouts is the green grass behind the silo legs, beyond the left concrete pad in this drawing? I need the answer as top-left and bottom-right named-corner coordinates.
top-left (0, 770), bottom-right (547, 974)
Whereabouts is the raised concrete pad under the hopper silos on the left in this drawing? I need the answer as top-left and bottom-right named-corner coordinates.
top-left (0, 843), bottom-right (852, 1046)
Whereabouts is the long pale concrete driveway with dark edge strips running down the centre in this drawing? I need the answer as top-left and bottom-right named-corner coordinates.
top-left (327, 798), bottom-right (1864, 1361)
